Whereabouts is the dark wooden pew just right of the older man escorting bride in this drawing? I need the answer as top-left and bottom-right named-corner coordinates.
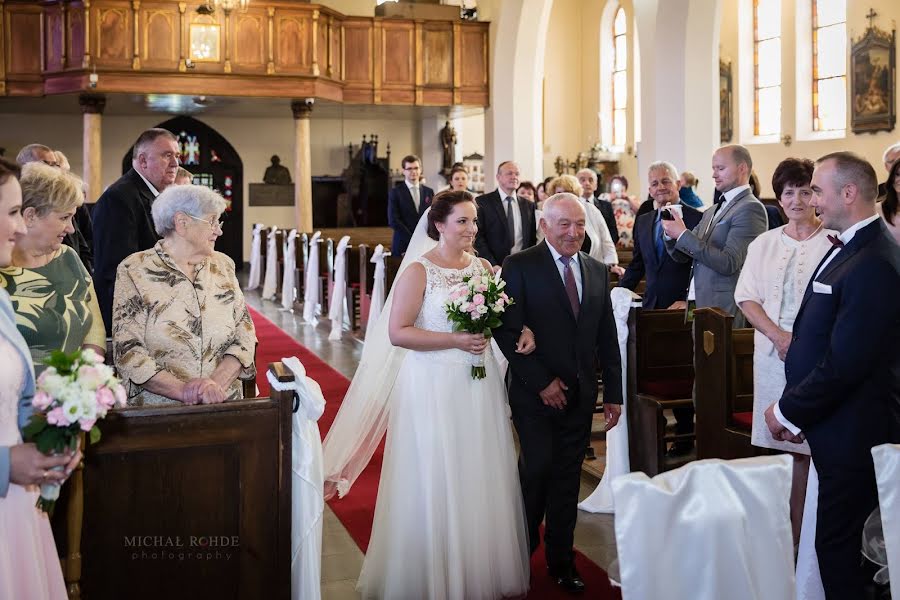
top-left (626, 308), bottom-right (694, 477)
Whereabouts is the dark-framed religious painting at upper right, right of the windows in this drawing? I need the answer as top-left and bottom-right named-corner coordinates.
top-left (850, 25), bottom-right (897, 133)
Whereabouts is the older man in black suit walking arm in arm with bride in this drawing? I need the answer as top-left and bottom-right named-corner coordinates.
top-left (496, 193), bottom-right (622, 593)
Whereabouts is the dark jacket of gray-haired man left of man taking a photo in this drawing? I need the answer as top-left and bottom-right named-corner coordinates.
top-left (619, 204), bottom-right (703, 310)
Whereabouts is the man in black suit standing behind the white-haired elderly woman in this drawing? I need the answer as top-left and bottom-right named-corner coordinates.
top-left (92, 128), bottom-right (179, 335)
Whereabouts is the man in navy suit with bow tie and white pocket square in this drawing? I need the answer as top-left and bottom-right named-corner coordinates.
top-left (765, 152), bottom-right (900, 600)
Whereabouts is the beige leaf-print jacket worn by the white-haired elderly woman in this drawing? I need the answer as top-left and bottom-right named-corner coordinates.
top-left (113, 241), bottom-right (256, 406)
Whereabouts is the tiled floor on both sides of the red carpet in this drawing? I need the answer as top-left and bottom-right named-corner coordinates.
top-left (246, 292), bottom-right (616, 600)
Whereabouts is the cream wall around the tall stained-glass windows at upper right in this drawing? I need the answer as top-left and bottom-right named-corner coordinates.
top-left (720, 0), bottom-right (900, 202)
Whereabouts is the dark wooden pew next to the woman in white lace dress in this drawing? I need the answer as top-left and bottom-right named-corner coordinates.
top-left (694, 308), bottom-right (769, 459)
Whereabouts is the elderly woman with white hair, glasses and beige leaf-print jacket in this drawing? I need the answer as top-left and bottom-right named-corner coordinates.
top-left (112, 185), bottom-right (256, 406)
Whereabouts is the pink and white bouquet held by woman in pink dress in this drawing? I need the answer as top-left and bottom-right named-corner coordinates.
top-left (23, 349), bottom-right (126, 513)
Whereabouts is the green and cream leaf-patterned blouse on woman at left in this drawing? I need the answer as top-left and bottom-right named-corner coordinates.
top-left (0, 246), bottom-right (106, 374)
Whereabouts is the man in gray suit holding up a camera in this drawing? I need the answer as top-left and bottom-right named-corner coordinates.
top-left (663, 145), bottom-right (768, 327)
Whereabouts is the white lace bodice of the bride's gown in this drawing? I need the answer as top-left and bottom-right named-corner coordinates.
top-left (415, 256), bottom-right (490, 364)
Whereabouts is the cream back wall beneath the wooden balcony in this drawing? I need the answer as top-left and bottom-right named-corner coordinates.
top-left (0, 111), bottom-right (419, 260)
